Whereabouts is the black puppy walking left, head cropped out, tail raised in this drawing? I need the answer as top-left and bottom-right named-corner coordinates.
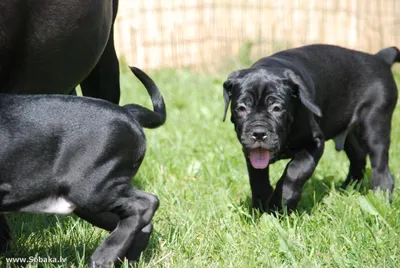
top-left (0, 68), bottom-right (166, 267)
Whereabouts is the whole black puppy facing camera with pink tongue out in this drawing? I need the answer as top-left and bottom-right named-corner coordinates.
top-left (223, 45), bottom-right (400, 211)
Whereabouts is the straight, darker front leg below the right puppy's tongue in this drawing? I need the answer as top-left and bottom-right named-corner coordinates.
top-left (246, 158), bottom-right (273, 212)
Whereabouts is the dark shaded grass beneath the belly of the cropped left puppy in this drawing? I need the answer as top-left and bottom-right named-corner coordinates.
top-left (0, 213), bottom-right (99, 267)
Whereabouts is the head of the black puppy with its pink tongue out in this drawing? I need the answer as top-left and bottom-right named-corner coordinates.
top-left (223, 68), bottom-right (321, 169)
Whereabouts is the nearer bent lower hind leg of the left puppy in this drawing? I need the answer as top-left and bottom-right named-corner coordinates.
top-left (90, 188), bottom-right (159, 267)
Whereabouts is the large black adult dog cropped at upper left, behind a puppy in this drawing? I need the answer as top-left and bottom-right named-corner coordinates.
top-left (0, 0), bottom-right (120, 252)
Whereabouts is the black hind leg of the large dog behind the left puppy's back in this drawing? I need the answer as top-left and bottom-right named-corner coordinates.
top-left (81, 0), bottom-right (120, 104)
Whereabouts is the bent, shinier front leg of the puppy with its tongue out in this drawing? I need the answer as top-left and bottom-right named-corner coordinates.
top-left (269, 138), bottom-right (324, 211)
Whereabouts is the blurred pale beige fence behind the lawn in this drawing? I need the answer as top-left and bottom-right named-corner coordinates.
top-left (115, 0), bottom-right (400, 73)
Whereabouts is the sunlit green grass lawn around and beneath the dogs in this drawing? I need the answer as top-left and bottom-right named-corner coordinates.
top-left (2, 69), bottom-right (400, 267)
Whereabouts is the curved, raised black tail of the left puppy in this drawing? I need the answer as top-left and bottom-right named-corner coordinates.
top-left (124, 67), bottom-right (167, 128)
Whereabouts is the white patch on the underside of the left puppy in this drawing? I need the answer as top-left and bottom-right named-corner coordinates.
top-left (19, 196), bottom-right (76, 214)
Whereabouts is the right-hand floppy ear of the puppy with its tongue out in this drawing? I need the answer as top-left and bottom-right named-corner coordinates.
top-left (285, 70), bottom-right (322, 117)
